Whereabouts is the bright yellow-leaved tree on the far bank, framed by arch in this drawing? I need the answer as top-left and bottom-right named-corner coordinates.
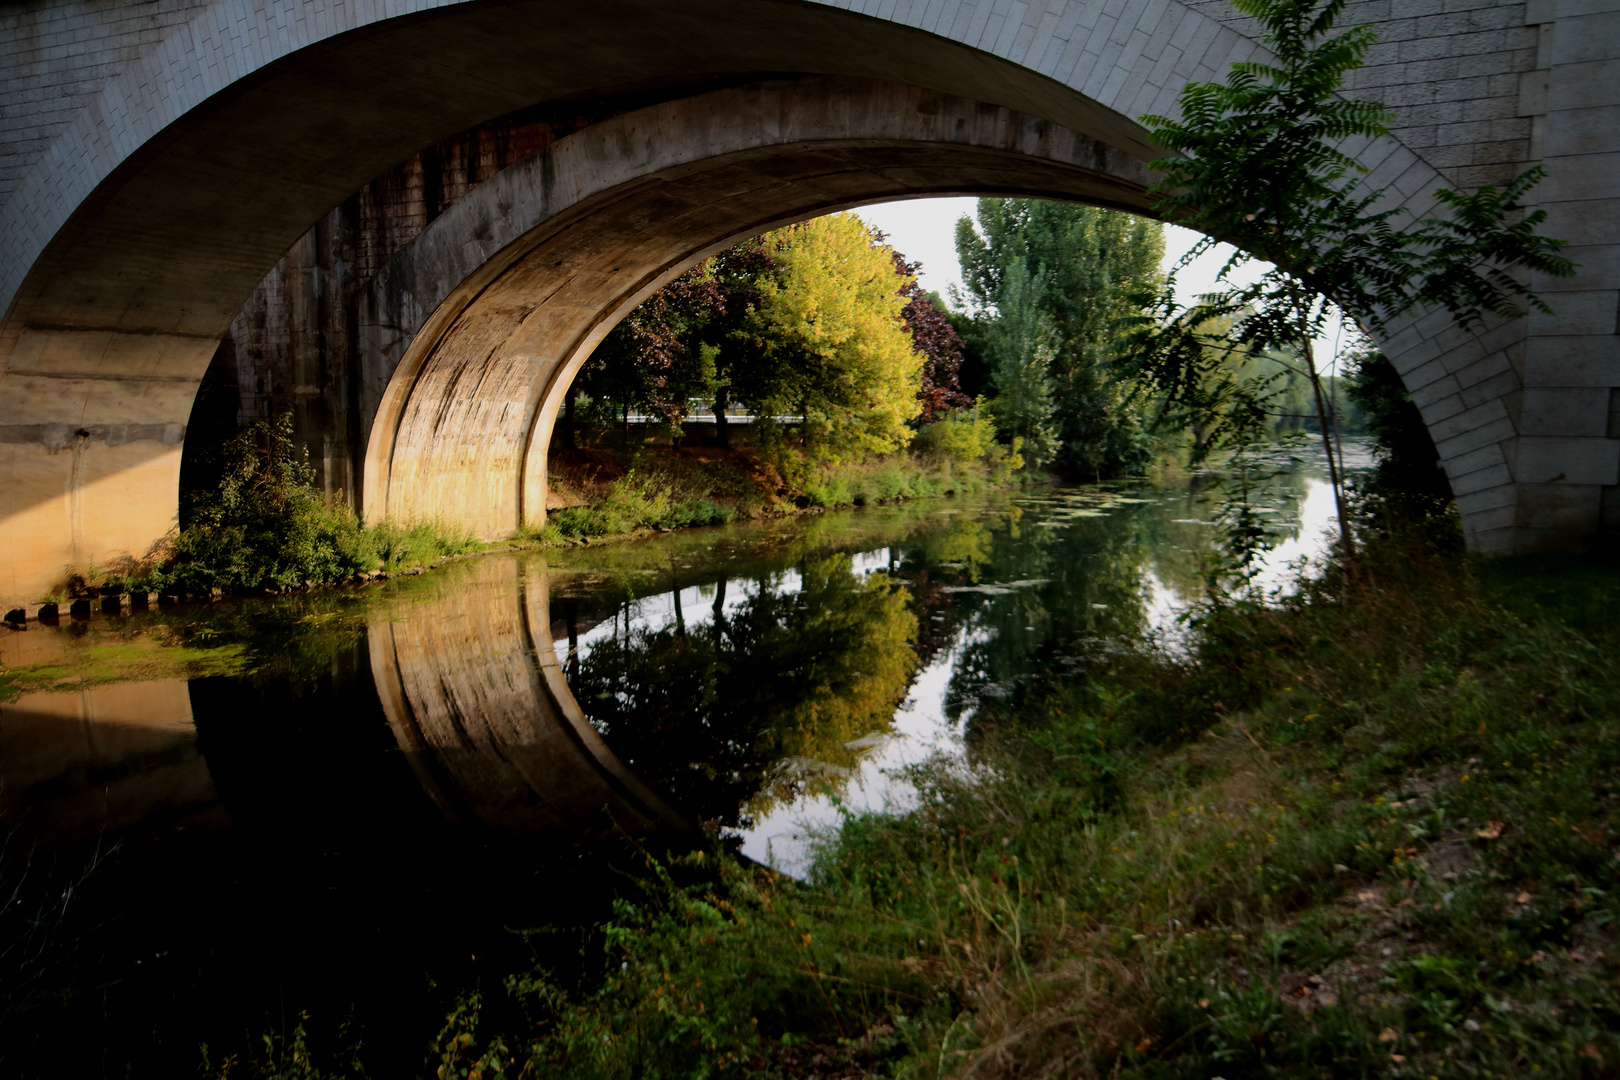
top-left (755, 214), bottom-right (923, 461)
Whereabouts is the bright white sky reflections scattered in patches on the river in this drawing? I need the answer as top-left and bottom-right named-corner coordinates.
top-left (559, 447), bottom-right (1369, 874)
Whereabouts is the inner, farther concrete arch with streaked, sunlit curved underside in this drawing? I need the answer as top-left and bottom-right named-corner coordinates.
top-left (358, 78), bottom-right (1149, 538)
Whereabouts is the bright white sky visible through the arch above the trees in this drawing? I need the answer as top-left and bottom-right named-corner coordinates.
top-left (855, 198), bottom-right (1335, 369)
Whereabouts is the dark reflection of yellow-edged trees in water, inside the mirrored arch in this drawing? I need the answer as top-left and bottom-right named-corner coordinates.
top-left (569, 555), bottom-right (917, 826)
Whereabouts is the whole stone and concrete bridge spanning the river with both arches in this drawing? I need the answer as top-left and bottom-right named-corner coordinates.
top-left (0, 0), bottom-right (1620, 601)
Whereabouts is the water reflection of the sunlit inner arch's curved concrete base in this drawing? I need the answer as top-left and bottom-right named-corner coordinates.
top-left (369, 557), bottom-right (693, 837)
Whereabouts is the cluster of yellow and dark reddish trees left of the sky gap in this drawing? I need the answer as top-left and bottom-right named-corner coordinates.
top-left (576, 214), bottom-right (946, 457)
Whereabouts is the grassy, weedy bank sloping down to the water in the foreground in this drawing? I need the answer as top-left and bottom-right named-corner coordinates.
top-left (392, 514), bottom-right (1620, 1078)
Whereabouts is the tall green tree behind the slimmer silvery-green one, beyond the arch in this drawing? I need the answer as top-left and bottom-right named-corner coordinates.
top-left (956, 199), bottom-right (1165, 476)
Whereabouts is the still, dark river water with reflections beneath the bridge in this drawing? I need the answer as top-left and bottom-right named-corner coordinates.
top-left (0, 446), bottom-right (1360, 1077)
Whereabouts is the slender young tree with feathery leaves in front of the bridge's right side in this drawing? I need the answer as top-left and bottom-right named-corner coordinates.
top-left (1123, 0), bottom-right (1573, 554)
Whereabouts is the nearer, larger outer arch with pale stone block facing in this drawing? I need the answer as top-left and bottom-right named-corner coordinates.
top-left (0, 0), bottom-right (1620, 597)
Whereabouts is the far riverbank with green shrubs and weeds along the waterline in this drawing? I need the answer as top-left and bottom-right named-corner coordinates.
top-left (0, 411), bottom-right (1032, 612)
